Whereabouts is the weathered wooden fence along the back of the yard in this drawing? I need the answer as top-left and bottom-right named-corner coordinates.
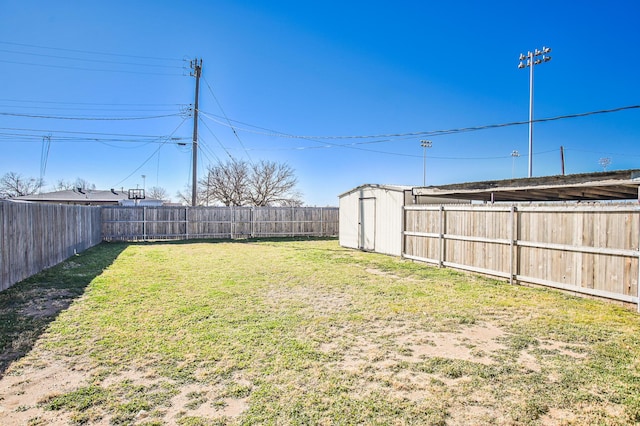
top-left (102, 206), bottom-right (338, 241)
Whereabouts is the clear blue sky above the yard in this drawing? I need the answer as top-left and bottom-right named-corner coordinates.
top-left (0, 0), bottom-right (640, 206)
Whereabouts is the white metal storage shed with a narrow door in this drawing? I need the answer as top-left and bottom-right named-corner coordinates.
top-left (339, 184), bottom-right (413, 256)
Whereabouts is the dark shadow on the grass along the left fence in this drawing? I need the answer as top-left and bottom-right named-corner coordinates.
top-left (0, 243), bottom-right (129, 378)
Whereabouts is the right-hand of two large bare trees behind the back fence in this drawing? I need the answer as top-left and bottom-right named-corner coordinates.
top-left (249, 161), bottom-right (302, 206)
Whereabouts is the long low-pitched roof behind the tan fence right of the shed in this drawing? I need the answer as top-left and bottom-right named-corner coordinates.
top-left (413, 169), bottom-right (640, 201)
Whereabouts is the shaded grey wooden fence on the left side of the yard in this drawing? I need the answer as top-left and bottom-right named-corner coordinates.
top-left (0, 200), bottom-right (102, 291)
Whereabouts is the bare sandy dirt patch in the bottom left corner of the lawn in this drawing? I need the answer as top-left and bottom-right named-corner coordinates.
top-left (0, 352), bottom-right (252, 425)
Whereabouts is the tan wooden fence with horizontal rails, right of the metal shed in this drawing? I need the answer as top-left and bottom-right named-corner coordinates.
top-left (402, 204), bottom-right (640, 310)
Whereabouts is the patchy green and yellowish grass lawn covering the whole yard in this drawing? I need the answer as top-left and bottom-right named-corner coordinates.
top-left (0, 240), bottom-right (640, 426)
